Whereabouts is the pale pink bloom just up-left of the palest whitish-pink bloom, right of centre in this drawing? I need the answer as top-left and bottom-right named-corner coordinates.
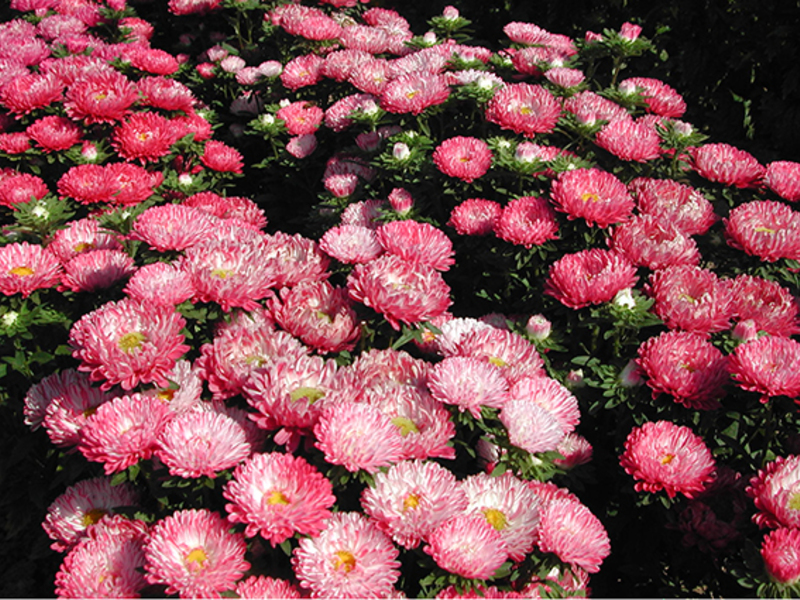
top-left (428, 356), bottom-right (508, 419)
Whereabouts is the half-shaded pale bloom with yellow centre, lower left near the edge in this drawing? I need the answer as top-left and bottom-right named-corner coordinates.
top-left (42, 477), bottom-right (139, 552)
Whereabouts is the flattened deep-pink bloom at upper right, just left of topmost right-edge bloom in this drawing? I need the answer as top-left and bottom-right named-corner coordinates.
top-left (690, 144), bottom-right (765, 188)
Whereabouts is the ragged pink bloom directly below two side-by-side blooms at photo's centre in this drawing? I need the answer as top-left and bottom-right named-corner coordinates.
top-left (347, 254), bottom-right (451, 330)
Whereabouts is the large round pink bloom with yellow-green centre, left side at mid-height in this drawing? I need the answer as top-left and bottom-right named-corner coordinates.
top-left (69, 299), bottom-right (189, 390)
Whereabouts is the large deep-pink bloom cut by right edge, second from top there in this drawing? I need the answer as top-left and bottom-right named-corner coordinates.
top-left (723, 200), bottom-right (800, 262)
